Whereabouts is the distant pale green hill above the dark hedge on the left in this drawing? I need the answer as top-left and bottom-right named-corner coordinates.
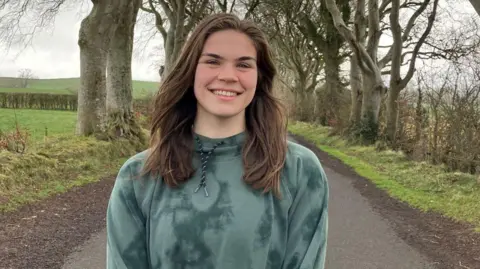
top-left (0, 77), bottom-right (158, 98)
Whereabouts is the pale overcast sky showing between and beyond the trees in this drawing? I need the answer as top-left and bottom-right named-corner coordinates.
top-left (0, 0), bottom-right (475, 81)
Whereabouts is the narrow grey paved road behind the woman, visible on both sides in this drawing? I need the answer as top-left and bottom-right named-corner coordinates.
top-left (63, 162), bottom-right (434, 269)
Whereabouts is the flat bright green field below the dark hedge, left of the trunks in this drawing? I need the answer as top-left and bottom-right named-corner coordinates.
top-left (0, 108), bottom-right (77, 143)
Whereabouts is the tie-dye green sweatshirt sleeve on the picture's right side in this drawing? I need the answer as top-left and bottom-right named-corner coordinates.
top-left (282, 152), bottom-right (329, 269)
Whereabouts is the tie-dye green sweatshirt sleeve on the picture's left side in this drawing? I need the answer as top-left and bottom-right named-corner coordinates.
top-left (106, 162), bottom-right (149, 269)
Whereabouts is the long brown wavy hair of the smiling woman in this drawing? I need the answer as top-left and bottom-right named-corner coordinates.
top-left (144, 14), bottom-right (287, 197)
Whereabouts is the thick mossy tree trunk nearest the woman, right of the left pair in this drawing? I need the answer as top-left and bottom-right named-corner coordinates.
top-left (106, 0), bottom-right (141, 141)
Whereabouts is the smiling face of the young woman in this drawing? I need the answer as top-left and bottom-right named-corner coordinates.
top-left (194, 30), bottom-right (258, 118)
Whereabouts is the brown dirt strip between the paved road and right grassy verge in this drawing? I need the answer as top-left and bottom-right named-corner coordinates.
top-left (291, 134), bottom-right (480, 269)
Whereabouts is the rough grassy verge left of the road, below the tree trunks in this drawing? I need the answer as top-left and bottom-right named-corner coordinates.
top-left (0, 135), bottom-right (144, 212)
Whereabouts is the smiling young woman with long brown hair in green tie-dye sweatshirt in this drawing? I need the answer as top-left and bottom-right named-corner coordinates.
top-left (107, 14), bottom-right (328, 269)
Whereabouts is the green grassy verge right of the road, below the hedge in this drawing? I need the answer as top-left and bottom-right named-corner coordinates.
top-left (289, 122), bottom-right (480, 232)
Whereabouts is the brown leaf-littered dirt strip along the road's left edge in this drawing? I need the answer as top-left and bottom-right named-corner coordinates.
top-left (0, 177), bottom-right (115, 269)
